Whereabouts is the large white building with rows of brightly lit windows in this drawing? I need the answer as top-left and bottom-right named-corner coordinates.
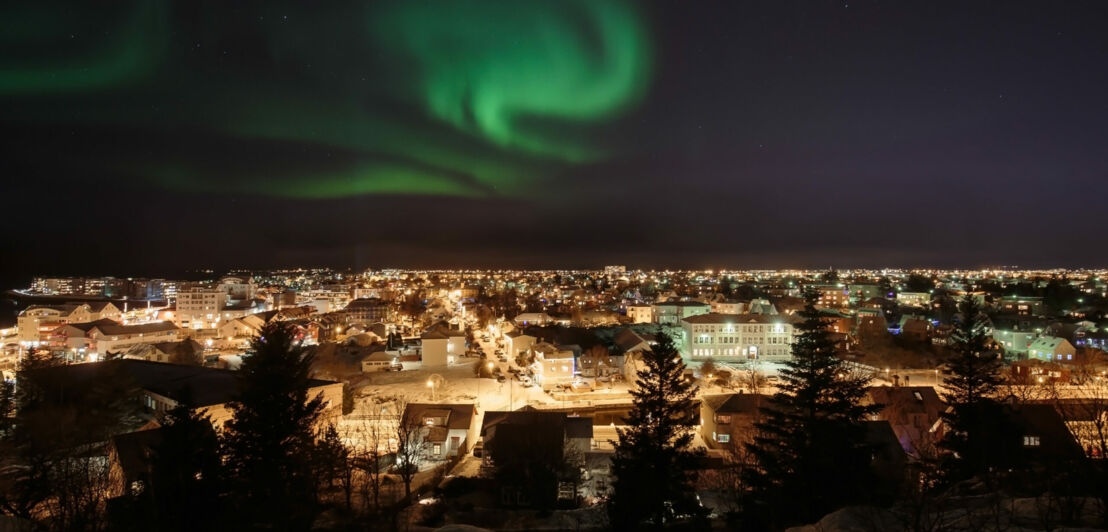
top-left (681, 313), bottom-right (798, 360)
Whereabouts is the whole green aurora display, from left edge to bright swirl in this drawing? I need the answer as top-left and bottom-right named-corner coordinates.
top-left (0, 0), bottom-right (652, 198)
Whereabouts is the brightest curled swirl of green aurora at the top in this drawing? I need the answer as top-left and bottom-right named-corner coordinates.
top-left (373, 0), bottom-right (648, 161)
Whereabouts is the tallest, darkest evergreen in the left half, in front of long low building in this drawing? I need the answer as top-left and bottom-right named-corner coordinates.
top-left (225, 323), bottom-right (322, 530)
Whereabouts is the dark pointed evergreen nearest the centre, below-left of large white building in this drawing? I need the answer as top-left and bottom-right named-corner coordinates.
top-left (608, 334), bottom-right (701, 530)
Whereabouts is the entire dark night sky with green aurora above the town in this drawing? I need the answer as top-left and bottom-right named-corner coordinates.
top-left (0, 0), bottom-right (1108, 285)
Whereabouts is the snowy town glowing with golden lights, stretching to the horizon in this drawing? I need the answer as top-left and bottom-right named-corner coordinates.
top-left (2, 266), bottom-right (1108, 525)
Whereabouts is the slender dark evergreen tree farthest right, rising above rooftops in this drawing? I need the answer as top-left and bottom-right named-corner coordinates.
top-left (942, 294), bottom-right (1003, 479)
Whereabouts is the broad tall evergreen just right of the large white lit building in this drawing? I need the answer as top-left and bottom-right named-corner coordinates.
top-left (743, 291), bottom-right (876, 529)
